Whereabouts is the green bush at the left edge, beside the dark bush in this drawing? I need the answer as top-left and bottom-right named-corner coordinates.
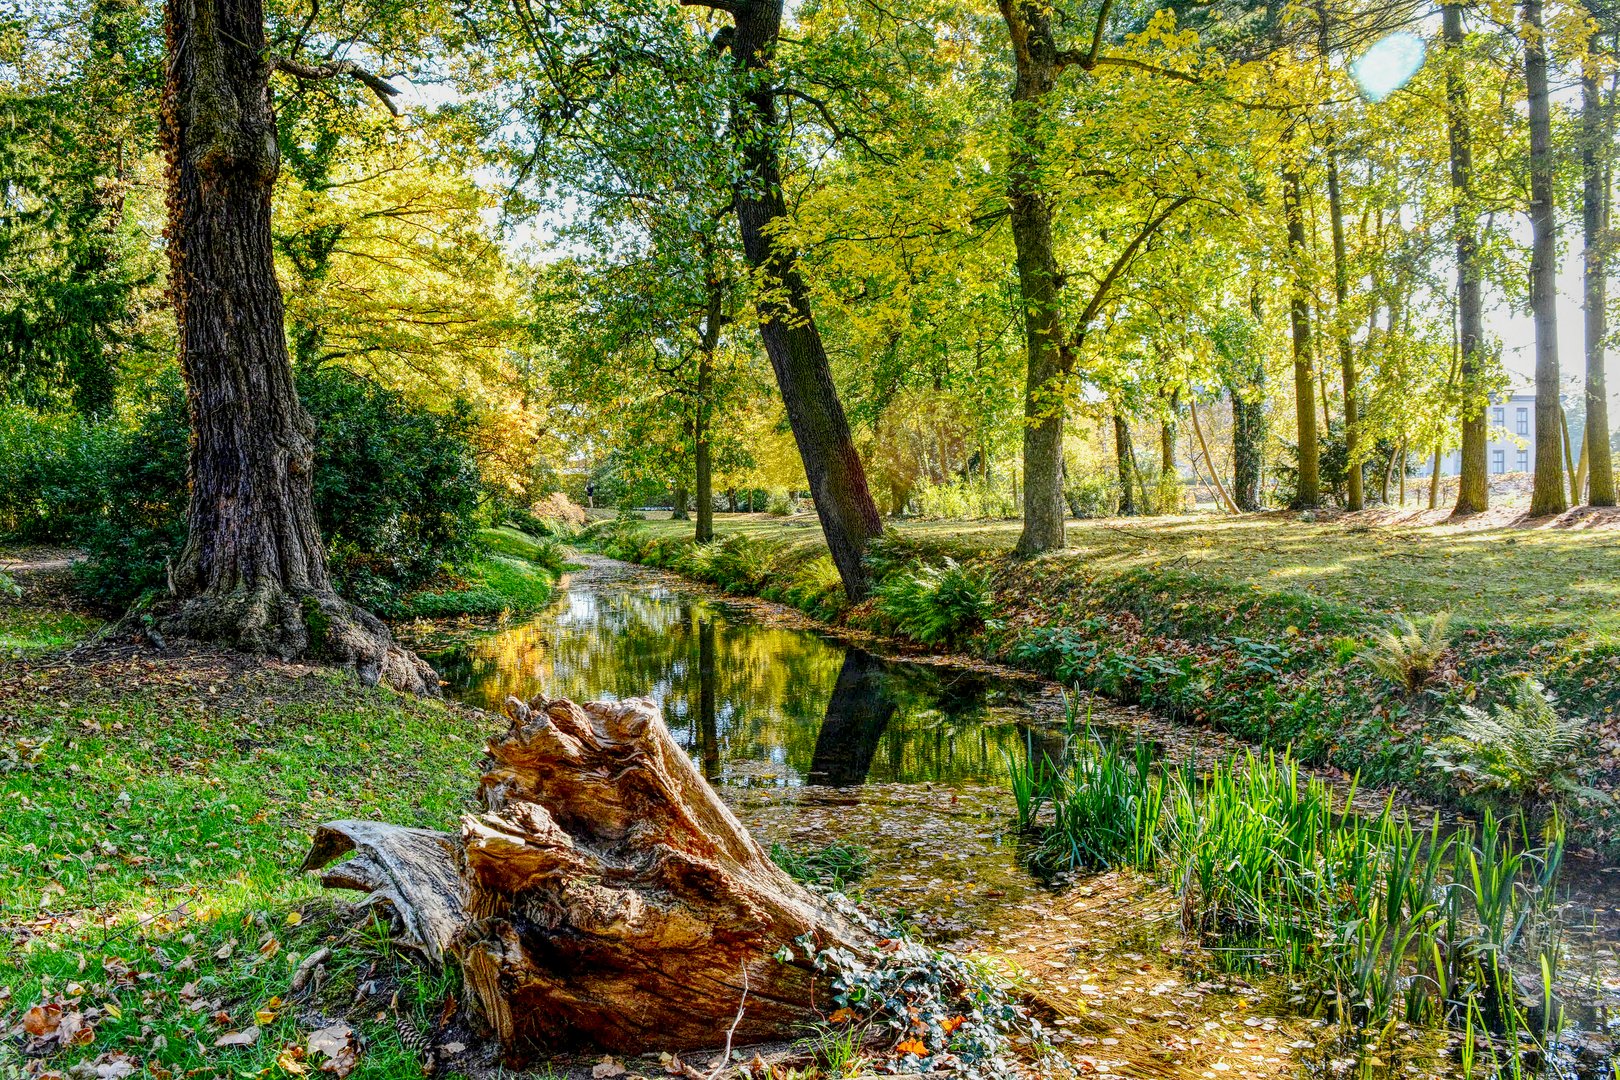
top-left (0, 405), bottom-right (126, 542)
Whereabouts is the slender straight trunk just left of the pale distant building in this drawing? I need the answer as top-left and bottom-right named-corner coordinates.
top-left (1440, 3), bottom-right (1490, 513)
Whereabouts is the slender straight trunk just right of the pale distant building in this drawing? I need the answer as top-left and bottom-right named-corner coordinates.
top-left (1521, 0), bottom-right (1570, 517)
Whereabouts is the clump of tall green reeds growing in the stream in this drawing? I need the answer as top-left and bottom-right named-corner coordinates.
top-left (1009, 724), bottom-right (1563, 1068)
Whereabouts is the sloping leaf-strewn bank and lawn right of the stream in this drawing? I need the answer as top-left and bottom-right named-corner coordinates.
top-left (586, 513), bottom-right (1620, 858)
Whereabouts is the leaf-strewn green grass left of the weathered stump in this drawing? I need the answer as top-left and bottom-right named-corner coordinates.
top-left (0, 661), bottom-right (491, 1078)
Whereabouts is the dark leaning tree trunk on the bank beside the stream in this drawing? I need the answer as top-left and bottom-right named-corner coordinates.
top-left (731, 0), bottom-right (883, 601)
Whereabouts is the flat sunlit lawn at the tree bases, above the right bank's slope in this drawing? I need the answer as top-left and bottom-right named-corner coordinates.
top-left (628, 515), bottom-right (1620, 636)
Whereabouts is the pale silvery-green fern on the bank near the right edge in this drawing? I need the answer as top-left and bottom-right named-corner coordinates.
top-left (1429, 675), bottom-right (1610, 810)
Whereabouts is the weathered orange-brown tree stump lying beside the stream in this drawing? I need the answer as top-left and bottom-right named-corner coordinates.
top-left (305, 698), bottom-right (873, 1061)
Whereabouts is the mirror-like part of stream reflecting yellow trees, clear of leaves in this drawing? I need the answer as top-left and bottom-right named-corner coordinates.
top-left (433, 583), bottom-right (1024, 785)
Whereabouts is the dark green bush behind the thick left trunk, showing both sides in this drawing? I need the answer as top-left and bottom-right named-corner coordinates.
top-left (79, 371), bottom-right (480, 610)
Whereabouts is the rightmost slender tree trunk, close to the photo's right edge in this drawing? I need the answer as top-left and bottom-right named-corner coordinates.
top-left (1581, 63), bottom-right (1615, 507)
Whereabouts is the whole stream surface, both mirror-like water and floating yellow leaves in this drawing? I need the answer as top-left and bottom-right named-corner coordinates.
top-left (418, 555), bottom-right (1620, 1077)
